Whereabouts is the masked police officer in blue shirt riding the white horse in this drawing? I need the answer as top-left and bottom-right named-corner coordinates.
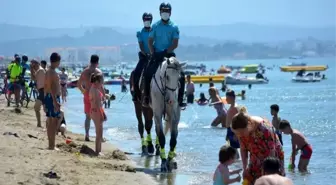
top-left (142, 3), bottom-right (186, 107)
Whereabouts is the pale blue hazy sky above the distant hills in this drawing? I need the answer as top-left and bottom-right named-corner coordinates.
top-left (0, 0), bottom-right (336, 28)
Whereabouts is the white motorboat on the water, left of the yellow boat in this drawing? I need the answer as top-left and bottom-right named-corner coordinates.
top-left (225, 75), bottom-right (268, 85)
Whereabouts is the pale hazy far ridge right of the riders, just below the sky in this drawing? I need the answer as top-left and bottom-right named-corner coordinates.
top-left (181, 23), bottom-right (336, 42)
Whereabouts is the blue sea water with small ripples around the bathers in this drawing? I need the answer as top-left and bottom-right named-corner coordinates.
top-left (64, 58), bottom-right (336, 185)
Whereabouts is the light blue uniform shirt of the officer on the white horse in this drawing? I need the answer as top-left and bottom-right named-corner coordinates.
top-left (149, 20), bottom-right (180, 52)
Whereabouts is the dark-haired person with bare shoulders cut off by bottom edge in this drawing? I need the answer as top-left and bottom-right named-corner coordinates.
top-left (254, 157), bottom-right (293, 185)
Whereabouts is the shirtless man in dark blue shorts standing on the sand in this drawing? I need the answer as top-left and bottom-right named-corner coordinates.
top-left (44, 53), bottom-right (61, 150)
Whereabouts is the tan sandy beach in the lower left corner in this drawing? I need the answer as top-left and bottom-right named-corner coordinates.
top-left (0, 96), bottom-right (157, 185)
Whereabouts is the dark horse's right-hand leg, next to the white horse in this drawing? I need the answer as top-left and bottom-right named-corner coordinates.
top-left (143, 107), bottom-right (154, 154)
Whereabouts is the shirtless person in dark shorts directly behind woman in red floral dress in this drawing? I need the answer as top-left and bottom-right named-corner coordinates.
top-left (226, 90), bottom-right (240, 149)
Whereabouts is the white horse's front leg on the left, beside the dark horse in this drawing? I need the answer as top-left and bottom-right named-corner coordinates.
top-left (154, 108), bottom-right (168, 172)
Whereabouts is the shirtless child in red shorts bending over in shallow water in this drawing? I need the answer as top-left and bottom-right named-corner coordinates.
top-left (279, 120), bottom-right (313, 172)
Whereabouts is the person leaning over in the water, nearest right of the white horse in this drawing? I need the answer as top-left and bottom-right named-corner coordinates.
top-left (209, 82), bottom-right (226, 127)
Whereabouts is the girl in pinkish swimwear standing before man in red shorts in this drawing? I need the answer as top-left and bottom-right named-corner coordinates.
top-left (89, 73), bottom-right (106, 155)
